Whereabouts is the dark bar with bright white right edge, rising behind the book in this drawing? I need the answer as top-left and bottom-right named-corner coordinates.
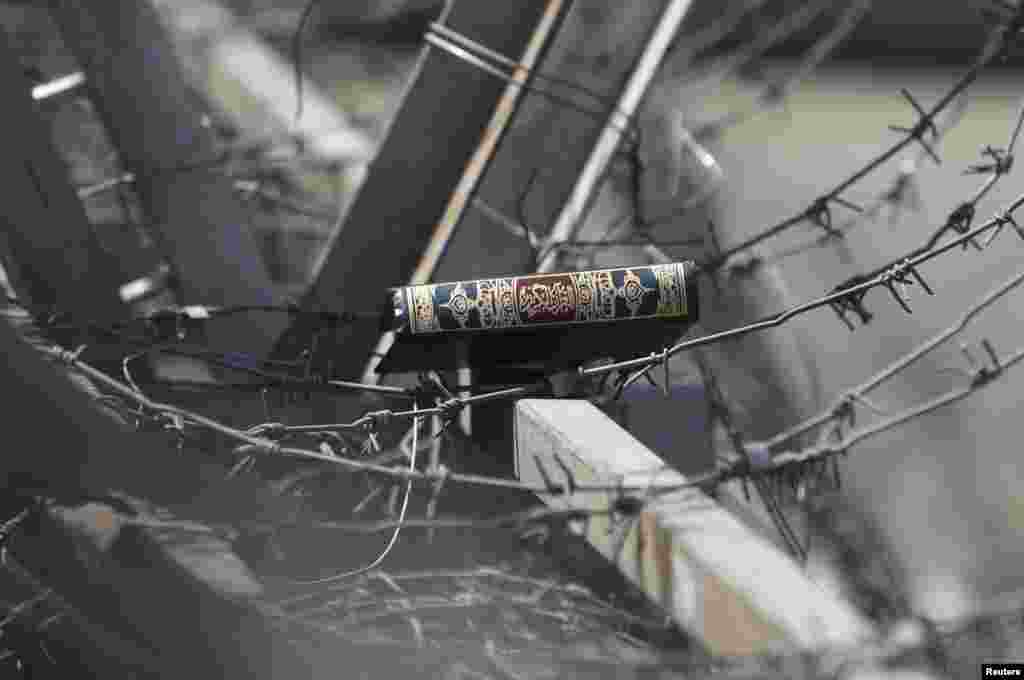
top-left (452, 2), bottom-right (700, 448)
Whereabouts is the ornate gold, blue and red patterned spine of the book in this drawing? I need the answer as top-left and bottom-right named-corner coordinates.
top-left (386, 262), bottom-right (697, 336)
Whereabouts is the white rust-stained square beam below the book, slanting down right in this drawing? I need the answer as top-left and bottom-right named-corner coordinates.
top-left (515, 399), bottom-right (878, 656)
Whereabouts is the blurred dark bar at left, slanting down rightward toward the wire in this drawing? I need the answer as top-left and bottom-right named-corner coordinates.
top-left (49, 0), bottom-right (286, 354)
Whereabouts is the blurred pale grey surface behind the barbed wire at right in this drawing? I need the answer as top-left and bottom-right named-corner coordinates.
top-left (708, 63), bottom-right (1024, 611)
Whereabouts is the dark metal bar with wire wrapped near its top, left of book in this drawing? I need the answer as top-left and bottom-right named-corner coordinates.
top-left (278, 0), bottom-right (551, 378)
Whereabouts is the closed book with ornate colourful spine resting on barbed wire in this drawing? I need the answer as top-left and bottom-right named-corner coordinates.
top-left (378, 262), bottom-right (698, 373)
